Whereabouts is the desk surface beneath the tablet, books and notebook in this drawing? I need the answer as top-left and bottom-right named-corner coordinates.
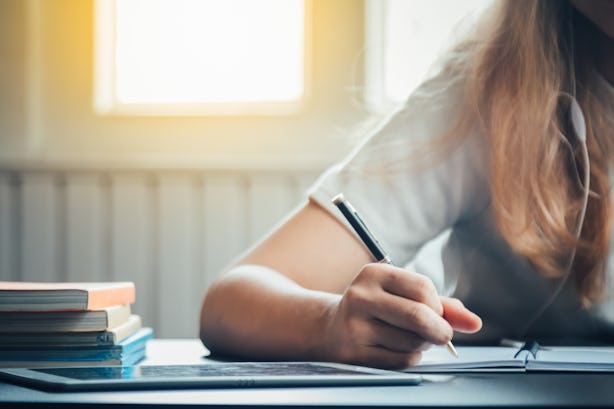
top-left (0, 340), bottom-right (614, 408)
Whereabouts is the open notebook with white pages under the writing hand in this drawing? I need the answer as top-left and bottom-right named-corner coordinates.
top-left (406, 342), bottom-right (614, 372)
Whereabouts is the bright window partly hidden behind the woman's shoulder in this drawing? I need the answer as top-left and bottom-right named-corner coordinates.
top-left (365, 0), bottom-right (492, 111)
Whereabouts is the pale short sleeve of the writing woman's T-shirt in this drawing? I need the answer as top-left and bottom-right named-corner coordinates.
top-left (308, 71), bottom-right (489, 265)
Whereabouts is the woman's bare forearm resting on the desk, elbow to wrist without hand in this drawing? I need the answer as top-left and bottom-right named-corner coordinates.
top-left (200, 265), bottom-right (341, 360)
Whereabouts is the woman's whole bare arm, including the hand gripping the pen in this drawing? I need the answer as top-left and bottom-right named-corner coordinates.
top-left (201, 198), bottom-right (479, 367)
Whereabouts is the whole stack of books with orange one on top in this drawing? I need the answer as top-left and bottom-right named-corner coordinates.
top-left (0, 281), bottom-right (153, 367)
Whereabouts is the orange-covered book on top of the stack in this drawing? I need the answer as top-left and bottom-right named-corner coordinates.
top-left (0, 281), bottom-right (136, 311)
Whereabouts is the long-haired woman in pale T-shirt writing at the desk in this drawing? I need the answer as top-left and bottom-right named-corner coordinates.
top-left (201, 0), bottom-right (614, 368)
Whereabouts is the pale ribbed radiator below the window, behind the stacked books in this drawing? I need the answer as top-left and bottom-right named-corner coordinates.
top-left (0, 170), bottom-right (317, 338)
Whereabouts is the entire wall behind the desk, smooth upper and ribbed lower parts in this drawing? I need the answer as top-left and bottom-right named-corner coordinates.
top-left (0, 0), bottom-right (366, 337)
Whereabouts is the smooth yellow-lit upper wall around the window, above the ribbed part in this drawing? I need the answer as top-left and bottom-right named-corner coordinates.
top-left (0, 0), bottom-right (364, 169)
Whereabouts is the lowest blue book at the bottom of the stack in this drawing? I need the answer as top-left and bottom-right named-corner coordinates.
top-left (0, 327), bottom-right (153, 360)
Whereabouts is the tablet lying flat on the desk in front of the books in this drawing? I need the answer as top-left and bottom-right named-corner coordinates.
top-left (0, 362), bottom-right (421, 391)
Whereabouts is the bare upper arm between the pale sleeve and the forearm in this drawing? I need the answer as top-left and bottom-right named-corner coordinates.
top-left (239, 201), bottom-right (372, 293)
